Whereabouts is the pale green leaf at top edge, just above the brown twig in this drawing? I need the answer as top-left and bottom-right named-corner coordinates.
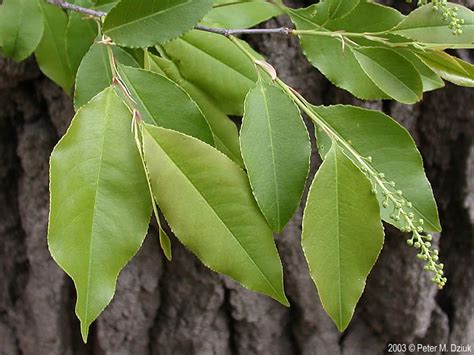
top-left (203, 0), bottom-right (282, 28)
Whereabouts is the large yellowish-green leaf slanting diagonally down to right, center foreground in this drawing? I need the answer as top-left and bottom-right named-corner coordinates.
top-left (144, 125), bottom-right (288, 305)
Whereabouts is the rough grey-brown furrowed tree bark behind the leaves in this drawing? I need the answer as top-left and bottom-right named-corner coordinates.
top-left (0, 1), bottom-right (474, 355)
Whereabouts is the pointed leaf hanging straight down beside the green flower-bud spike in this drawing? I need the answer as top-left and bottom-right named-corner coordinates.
top-left (302, 144), bottom-right (384, 332)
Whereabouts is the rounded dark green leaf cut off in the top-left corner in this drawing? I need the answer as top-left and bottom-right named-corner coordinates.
top-left (0, 0), bottom-right (44, 62)
